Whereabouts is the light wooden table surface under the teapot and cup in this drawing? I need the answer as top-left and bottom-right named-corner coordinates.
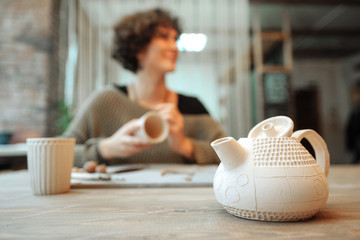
top-left (0, 165), bottom-right (360, 239)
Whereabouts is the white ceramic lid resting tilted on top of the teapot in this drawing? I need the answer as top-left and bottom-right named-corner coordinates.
top-left (248, 116), bottom-right (294, 138)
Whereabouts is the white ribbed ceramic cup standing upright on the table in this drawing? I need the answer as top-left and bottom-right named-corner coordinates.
top-left (26, 138), bottom-right (75, 195)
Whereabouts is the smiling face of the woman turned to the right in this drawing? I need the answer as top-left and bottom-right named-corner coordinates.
top-left (138, 27), bottom-right (179, 74)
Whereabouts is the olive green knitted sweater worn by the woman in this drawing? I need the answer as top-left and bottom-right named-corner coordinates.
top-left (63, 86), bottom-right (225, 167)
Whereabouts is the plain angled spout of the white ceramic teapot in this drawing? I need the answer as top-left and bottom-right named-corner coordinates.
top-left (211, 137), bottom-right (247, 170)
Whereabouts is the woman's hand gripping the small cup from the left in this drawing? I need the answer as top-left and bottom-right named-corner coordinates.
top-left (99, 119), bottom-right (152, 159)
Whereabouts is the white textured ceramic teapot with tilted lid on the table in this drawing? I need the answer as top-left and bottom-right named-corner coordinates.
top-left (211, 116), bottom-right (330, 221)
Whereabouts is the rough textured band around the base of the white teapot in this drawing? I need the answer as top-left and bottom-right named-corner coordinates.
top-left (223, 205), bottom-right (318, 222)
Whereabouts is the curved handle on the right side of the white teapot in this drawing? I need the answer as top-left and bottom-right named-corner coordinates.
top-left (292, 129), bottom-right (330, 177)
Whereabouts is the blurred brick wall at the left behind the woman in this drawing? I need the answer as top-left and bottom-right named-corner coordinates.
top-left (0, 0), bottom-right (58, 140)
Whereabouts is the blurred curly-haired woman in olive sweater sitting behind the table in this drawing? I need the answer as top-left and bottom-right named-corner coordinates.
top-left (64, 9), bottom-right (224, 166)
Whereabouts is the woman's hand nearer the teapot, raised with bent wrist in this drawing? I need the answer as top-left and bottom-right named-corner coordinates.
top-left (155, 103), bottom-right (194, 159)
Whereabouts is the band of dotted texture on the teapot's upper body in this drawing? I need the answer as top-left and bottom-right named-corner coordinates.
top-left (253, 138), bottom-right (316, 167)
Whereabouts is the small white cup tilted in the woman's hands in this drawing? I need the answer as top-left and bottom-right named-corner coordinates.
top-left (135, 111), bottom-right (169, 143)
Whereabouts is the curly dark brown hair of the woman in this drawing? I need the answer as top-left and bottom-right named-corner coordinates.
top-left (112, 8), bottom-right (181, 73)
